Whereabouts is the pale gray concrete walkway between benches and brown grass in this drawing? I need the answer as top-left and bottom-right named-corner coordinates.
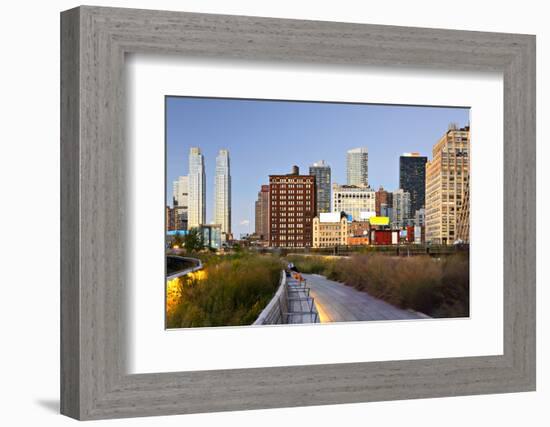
top-left (303, 274), bottom-right (428, 323)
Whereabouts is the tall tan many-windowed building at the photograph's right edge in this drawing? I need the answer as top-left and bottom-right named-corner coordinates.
top-left (426, 125), bottom-right (470, 245)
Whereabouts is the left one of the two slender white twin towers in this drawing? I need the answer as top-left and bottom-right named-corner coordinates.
top-left (188, 147), bottom-right (206, 228)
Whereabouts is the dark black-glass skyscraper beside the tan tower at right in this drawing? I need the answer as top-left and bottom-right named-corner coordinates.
top-left (399, 153), bottom-right (428, 215)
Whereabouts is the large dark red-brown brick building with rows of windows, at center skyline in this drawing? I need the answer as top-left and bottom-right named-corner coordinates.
top-left (269, 166), bottom-right (316, 248)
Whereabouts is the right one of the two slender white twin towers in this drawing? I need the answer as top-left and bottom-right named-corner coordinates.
top-left (214, 149), bottom-right (231, 239)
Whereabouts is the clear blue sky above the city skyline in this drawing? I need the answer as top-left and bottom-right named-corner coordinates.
top-left (166, 97), bottom-right (469, 237)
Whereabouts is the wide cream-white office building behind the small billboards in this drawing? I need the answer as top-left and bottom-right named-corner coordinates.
top-left (332, 183), bottom-right (376, 221)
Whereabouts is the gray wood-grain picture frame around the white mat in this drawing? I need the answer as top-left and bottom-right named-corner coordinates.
top-left (61, 6), bottom-right (535, 419)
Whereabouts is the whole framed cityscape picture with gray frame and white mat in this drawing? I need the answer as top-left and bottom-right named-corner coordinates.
top-left (61, 6), bottom-right (536, 419)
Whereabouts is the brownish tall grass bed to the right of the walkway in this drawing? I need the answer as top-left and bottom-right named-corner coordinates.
top-left (288, 254), bottom-right (470, 317)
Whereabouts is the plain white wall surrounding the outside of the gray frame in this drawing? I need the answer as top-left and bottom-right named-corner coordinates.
top-left (0, 0), bottom-right (550, 427)
